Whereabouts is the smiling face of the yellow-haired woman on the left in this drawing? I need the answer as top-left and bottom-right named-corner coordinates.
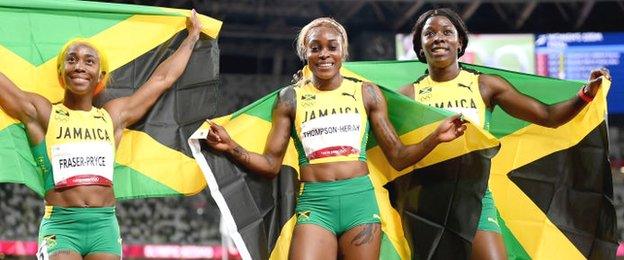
top-left (62, 43), bottom-right (103, 95)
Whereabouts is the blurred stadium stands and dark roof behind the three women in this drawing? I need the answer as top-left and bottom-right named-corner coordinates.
top-left (0, 0), bottom-right (624, 259)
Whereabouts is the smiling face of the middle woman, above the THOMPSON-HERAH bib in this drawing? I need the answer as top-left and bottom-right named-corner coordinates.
top-left (305, 26), bottom-right (344, 80)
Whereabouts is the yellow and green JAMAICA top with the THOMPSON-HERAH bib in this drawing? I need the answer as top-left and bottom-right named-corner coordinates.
top-left (292, 78), bottom-right (369, 165)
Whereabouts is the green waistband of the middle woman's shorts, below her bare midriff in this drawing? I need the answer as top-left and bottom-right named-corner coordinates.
top-left (301, 174), bottom-right (373, 196)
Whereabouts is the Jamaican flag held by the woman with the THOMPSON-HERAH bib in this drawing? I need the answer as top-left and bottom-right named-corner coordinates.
top-left (190, 64), bottom-right (499, 259)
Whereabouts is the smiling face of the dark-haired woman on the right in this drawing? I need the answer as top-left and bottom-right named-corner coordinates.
top-left (420, 16), bottom-right (463, 67)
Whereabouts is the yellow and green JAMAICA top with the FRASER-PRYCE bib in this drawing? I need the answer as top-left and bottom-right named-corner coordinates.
top-left (31, 104), bottom-right (115, 191)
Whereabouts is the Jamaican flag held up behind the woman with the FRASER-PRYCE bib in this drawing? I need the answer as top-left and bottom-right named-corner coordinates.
top-left (0, 0), bottom-right (221, 199)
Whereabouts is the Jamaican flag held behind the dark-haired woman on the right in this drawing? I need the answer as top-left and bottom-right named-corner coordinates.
top-left (347, 62), bottom-right (617, 259)
